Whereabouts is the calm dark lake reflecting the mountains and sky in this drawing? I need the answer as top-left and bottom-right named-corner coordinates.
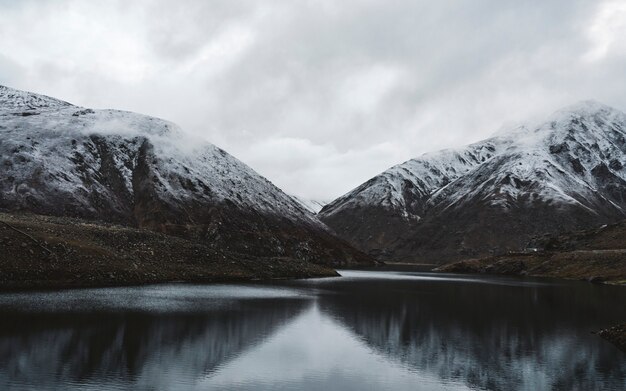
top-left (0, 271), bottom-right (626, 391)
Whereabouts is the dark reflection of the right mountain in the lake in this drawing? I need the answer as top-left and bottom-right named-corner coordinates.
top-left (320, 272), bottom-right (626, 390)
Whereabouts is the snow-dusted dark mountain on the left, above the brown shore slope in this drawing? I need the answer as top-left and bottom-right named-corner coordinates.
top-left (0, 86), bottom-right (370, 262)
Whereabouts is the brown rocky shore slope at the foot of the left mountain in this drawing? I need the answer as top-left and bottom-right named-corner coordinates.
top-left (0, 213), bottom-right (337, 290)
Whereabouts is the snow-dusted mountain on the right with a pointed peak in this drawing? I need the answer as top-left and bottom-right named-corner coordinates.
top-left (318, 101), bottom-right (626, 263)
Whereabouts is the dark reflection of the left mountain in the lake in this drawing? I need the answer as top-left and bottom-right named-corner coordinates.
top-left (0, 287), bottom-right (311, 390)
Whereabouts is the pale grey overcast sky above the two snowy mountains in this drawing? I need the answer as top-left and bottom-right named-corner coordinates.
top-left (0, 0), bottom-right (626, 200)
